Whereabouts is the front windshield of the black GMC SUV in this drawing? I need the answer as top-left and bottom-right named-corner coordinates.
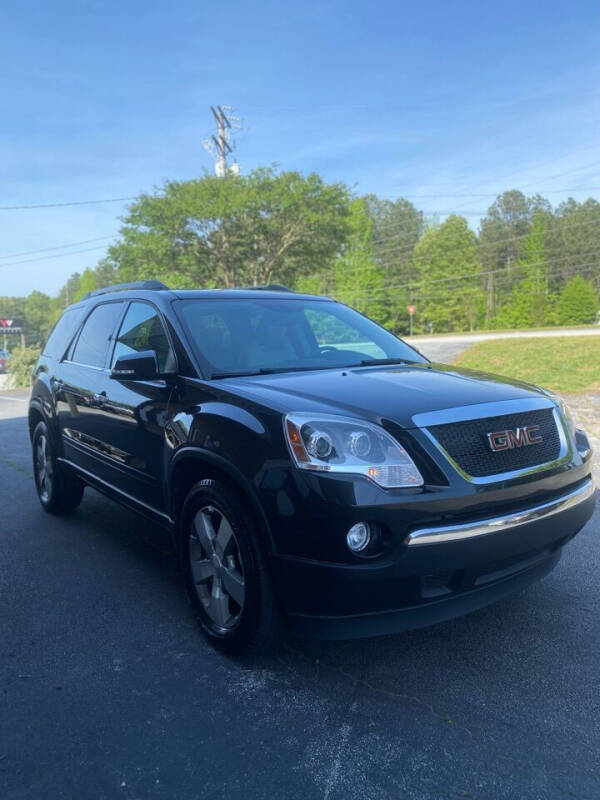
top-left (176, 297), bottom-right (426, 377)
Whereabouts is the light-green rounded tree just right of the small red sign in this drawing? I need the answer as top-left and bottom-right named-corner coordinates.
top-left (415, 214), bottom-right (484, 332)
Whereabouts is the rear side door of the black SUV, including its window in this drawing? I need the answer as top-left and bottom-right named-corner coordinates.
top-left (54, 301), bottom-right (125, 478)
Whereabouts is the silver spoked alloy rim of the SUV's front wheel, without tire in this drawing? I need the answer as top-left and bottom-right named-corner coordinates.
top-left (189, 506), bottom-right (245, 630)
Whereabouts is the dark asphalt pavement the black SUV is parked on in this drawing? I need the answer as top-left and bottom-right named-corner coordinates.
top-left (0, 394), bottom-right (600, 800)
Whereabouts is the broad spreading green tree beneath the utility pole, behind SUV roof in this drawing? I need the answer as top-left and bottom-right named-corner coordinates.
top-left (110, 169), bottom-right (350, 287)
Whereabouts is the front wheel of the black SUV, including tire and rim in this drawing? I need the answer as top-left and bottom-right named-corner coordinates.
top-left (179, 480), bottom-right (283, 655)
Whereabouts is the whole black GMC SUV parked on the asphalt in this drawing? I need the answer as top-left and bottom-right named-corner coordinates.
top-left (29, 281), bottom-right (594, 652)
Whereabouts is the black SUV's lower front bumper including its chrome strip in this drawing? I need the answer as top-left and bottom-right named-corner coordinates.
top-left (274, 476), bottom-right (595, 639)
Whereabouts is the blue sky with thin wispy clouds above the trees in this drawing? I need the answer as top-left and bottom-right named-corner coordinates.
top-left (0, 0), bottom-right (600, 295)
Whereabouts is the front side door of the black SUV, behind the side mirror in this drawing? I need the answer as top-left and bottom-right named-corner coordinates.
top-left (88, 300), bottom-right (176, 511)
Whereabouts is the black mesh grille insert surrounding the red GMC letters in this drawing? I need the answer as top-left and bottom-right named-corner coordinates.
top-left (428, 408), bottom-right (561, 478)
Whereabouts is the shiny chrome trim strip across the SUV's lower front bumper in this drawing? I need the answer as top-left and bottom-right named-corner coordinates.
top-left (406, 478), bottom-right (595, 547)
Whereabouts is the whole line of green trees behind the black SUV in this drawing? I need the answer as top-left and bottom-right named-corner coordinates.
top-left (0, 168), bottom-right (600, 346)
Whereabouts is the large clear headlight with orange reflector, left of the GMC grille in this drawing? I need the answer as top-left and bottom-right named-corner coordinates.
top-left (284, 413), bottom-right (423, 489)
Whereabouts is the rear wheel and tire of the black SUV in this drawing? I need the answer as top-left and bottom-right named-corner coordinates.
top-left (31, 422), bottom-right (85, 514)
